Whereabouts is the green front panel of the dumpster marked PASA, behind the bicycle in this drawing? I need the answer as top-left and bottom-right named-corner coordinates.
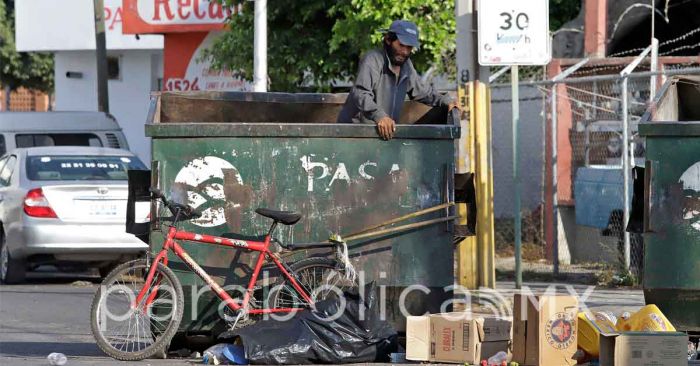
top-left (152, 137), bottom-right (454, 330)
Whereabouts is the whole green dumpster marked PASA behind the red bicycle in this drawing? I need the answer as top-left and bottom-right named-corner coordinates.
top-left (146, 92), bottom-right (459, 335)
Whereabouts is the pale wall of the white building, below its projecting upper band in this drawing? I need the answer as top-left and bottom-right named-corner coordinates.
top-left (55, 50), bottom-right (163, 164)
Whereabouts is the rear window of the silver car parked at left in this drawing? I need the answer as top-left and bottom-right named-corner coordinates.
top-left (27, 155), bottom-right (146, 180)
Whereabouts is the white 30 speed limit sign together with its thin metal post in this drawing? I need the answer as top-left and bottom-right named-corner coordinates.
top-left (478, 0), bottom-right (556, 289)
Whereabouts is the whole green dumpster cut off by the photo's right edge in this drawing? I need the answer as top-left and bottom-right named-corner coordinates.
top-left (639, 77), bottom-right (700, 332)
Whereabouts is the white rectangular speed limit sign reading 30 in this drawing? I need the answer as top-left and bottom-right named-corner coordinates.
top-left (478, 0), bottom-right (552, 66)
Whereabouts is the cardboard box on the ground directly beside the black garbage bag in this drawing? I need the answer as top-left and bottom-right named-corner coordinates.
top-left (429, 313), bottom-right (512, 363)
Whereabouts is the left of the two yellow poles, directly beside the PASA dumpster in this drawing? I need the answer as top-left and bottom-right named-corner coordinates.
top-left (457, 82), bottom-right (479, 289)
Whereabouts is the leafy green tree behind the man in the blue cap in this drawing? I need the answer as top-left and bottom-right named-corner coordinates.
top-left (205, 0), bottom-right (581, 91)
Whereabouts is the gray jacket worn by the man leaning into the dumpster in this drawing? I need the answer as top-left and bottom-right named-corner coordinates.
top-left (338, 49), bottom-right (452, 123)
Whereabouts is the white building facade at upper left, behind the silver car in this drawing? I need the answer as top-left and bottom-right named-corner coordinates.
top-left (15, 0), bottom-right (163, 162)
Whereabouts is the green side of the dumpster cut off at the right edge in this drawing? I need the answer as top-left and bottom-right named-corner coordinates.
top-left (644, 134), bottom-right (700, 331)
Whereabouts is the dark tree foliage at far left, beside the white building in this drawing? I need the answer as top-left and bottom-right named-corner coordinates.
top-left (0, 0), bottom-right (53, 92)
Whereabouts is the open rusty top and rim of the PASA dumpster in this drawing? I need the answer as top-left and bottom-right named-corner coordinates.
top-left (146, 92), bottom-right (460, 139)
